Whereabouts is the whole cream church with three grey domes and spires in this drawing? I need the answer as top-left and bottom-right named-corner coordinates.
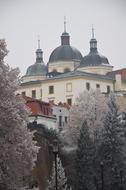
top-left (17, 21), bottom-right (126, 105)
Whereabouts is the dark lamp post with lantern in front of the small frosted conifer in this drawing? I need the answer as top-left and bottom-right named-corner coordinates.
top-left (53, 139), bottom-right (58, 190)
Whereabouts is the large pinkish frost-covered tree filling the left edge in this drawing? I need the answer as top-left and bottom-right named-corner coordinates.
top-left (0, 40), bottom-right (38, 190)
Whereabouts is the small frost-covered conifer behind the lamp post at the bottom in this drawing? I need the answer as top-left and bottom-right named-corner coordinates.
top-left (47, 156), bottom-right (72, 190)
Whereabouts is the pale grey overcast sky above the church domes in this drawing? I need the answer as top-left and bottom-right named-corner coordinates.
top-left (0, 0), bottom-right (126, 75)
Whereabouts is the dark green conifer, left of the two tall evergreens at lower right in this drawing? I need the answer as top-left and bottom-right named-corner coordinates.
top-left (76, 121), bottom-right (94, 190)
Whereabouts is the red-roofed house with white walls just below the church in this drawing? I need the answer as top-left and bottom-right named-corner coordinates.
top-left (22, 96), bottom-right (70, 130)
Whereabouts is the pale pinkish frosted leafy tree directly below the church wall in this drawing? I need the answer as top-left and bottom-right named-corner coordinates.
top-left (61, 90), bottom-right (107, 147)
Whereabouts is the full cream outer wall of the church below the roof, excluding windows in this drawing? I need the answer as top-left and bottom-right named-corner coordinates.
top-left (17, 78), bottom-right (114, 104)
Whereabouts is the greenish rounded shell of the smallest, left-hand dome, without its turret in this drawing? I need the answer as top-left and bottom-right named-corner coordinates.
top-left (26, 63), bottom-right (47, 76)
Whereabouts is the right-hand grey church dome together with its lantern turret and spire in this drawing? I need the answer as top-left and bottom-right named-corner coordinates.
top-left (79, 29), bottom-right (109, 67)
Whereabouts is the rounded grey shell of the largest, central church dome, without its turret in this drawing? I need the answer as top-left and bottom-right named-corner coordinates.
top-left (49, 45), bottom-right (82, 62)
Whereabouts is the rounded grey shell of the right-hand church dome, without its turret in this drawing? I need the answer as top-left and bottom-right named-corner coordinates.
top-left (80, 52), bottom-right (109, 67)
